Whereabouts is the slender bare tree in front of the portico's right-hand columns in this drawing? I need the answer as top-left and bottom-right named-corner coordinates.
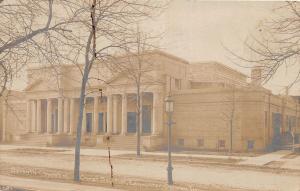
top-left (107, 26), bottom-right (158, 156)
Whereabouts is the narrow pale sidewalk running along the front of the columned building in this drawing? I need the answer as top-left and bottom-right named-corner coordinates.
top-left (0, 145), bottom-right (300, 170)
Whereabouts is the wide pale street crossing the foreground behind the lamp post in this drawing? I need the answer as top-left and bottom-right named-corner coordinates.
top-left (0, 145), bottom-right (300, 191)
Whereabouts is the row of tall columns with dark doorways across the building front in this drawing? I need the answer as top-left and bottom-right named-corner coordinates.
top-left (26, 92), bottom-right (163, 140)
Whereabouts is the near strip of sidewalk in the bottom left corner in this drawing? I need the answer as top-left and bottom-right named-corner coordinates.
top-left (0, 175), bottom-right (121, 191)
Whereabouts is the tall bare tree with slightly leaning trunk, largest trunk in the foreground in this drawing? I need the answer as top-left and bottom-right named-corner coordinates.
top-left (69, 0), bottom-right (164, 181)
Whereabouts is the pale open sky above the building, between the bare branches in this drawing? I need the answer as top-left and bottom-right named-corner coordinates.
top-left (12, 0), bottom-right (300, 94)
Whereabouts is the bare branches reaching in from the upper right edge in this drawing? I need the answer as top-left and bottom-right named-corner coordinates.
top-left (226, 1), bottom-right (300, 87)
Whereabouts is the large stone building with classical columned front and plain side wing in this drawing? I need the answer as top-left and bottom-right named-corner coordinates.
top-left (0, 51), bottom-right (300, 152)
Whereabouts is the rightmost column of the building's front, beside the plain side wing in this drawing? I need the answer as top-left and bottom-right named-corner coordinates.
top-left (152, 92), bottom-right (163, 135)
